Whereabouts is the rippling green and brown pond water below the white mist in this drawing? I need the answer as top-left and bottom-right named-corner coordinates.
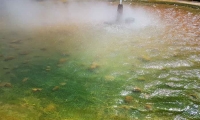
top-left (0, 1), bottom-right (200, 120)
